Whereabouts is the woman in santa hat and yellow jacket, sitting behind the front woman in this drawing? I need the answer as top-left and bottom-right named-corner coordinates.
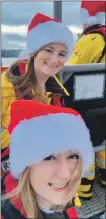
top-left (1, 13), bottom-right (73, 176)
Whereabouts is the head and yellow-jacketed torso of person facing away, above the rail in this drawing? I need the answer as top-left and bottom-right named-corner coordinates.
top-left (68, 0), bottom-right (106, 64)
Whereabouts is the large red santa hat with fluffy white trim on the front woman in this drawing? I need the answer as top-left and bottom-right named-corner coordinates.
top-left (8, 100), bottom-right (94, 178)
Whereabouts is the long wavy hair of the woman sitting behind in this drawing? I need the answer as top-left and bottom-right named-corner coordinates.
top-left (6, 52), bottom-right (48, 103)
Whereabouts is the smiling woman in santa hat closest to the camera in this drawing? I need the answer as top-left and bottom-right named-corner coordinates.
top-left (1, 100), bottom-right (94, 219)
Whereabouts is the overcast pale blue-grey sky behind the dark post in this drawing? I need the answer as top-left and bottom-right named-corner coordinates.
top-left (1, 1), bottom-right (82, 49)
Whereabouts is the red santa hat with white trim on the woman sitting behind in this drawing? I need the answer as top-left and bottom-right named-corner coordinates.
top-left (20, 13), bottom-right (74, 59)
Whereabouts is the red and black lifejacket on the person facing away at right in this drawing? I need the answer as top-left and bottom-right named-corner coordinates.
top-left (78, 24), bottom-right (106, 63)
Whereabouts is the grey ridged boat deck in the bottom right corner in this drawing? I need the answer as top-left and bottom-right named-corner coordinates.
top-left (77, 176), bottom-right (106, 219)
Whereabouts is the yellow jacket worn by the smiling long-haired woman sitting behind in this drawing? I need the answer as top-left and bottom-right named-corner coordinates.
top-left (1, 72), bottom-right (68, 149)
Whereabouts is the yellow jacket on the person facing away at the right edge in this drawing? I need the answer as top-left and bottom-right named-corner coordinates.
top-left (68, 33), bottom-right (106, 64)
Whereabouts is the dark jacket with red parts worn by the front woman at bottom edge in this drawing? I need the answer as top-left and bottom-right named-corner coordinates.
top-left (1, 173), bottom-right (77, 219)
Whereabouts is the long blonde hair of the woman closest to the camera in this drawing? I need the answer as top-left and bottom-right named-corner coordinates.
top-left (2, 160), bottom-right (82, 218)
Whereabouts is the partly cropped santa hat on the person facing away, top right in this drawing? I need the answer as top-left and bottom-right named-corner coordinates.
top-left (80, 0), bottom-right (106, 26)
